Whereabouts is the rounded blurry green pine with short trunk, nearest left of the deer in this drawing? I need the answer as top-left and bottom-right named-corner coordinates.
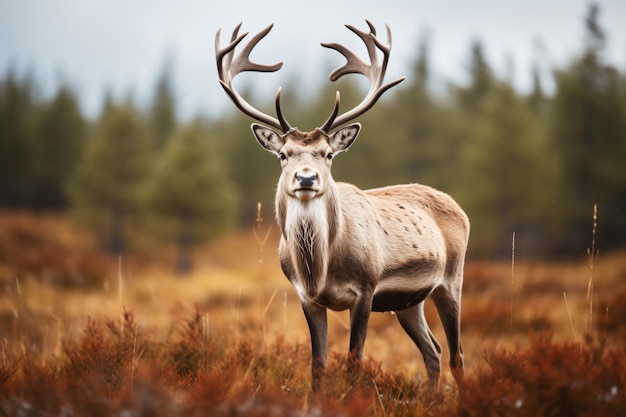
top-left (146, 121), bottom-right (236, 274)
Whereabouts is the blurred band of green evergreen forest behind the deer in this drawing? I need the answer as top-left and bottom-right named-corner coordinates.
top-left (0, 6), bottom-right (626, 260)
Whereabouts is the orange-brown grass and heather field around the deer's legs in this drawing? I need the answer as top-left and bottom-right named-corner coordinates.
top-left (0, 213), bottom-right (626, 417)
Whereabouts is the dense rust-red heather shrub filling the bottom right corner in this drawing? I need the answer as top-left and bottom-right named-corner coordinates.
top-left (459, 335), bottom-right (626, 416)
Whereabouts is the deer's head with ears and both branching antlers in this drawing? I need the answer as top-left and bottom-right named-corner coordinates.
top-left (215, 20), bottom-right (404, 201)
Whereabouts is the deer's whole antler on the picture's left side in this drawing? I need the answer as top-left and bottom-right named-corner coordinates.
top-left (215, 23), bottom-right (291, 133)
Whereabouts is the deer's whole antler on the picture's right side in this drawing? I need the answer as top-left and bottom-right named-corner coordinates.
top-left (320, 19), bottom-right (405, 132)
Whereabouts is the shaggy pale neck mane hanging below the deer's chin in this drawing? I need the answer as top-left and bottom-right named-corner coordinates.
top-left (276, 187), bottom-right (342, 296)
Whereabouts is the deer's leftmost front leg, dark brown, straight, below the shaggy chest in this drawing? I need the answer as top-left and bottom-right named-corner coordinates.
top-left (302, 301), bottom-right (328, 391)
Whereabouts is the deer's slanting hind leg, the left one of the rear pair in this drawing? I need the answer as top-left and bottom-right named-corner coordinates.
top-left (396, 302), bottom-right (441, 387)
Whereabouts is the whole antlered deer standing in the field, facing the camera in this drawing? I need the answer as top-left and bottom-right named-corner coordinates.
top-left (215, 20), bottom-right (470, 391)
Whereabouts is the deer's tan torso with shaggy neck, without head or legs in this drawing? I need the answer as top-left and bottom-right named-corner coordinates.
top-left (276, 183), bottom-right (469, 311)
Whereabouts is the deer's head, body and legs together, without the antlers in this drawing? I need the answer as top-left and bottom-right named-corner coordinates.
top-left (253, 125), bottom-right (469, 385)
